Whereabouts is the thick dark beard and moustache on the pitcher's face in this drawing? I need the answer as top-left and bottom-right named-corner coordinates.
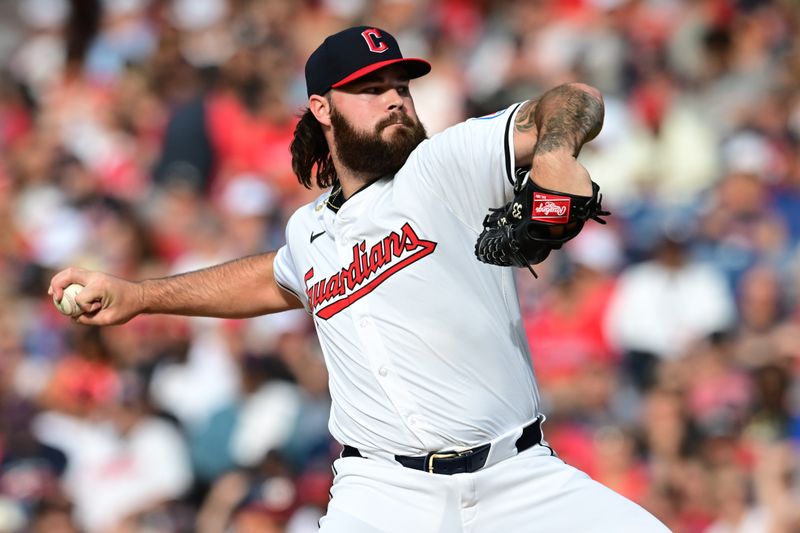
top-left (331, 108), bottom-right (428, 179)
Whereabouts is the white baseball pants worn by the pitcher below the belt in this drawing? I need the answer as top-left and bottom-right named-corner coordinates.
top-left (320, 445), bottom-right (669, 533)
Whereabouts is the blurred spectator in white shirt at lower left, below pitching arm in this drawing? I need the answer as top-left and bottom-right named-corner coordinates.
top-left (34, 373), bottom-right (192, 532)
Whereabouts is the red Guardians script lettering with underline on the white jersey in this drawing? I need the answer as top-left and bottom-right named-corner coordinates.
top-left (303, 223), bottom-right (437, 320)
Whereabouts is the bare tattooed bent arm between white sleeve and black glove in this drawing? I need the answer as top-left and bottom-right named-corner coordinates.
top-left (514, 83), bottom-right (603, 195)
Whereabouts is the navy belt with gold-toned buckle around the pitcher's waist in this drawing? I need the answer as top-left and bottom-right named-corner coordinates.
top-left (342, 418), bottom-right (542, 476)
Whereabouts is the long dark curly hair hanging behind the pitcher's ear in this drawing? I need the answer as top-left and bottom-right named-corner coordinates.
top-left (289, 109), bottom-right (336, 189)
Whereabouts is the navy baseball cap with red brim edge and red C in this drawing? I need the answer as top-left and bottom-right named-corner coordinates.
top-left (306, 26), bottom-right (431, 96)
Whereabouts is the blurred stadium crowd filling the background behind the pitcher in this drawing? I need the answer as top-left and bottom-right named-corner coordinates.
top-left (0, 0), bottom-right (800, 533)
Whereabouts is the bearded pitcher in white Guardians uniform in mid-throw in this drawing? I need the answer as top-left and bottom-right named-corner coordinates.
top-left (50, 26), bottom-right (667, 533)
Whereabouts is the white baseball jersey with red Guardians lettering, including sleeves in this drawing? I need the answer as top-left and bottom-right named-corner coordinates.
top-left (275, 104), bottom-right (538, 455)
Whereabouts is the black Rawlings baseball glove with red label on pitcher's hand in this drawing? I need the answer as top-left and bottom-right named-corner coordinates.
top-left (475, 171), bottom-right (611, 276)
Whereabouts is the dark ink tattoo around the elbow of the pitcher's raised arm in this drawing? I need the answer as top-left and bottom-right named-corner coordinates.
top-left (533, 85), bottom-right (603, 155)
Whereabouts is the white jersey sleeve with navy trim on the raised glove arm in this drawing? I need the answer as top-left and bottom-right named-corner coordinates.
top-left (409, 104), bottom-right (521, 231)
